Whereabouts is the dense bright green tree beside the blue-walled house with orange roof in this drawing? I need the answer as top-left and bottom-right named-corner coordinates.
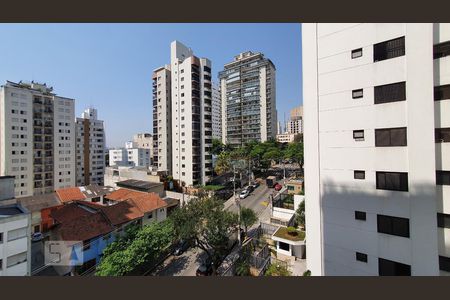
top-left (96, 220), bottom-right (175, 276)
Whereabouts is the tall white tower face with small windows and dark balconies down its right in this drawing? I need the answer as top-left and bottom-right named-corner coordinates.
top-left (170, 41), bottom-right (212, 186)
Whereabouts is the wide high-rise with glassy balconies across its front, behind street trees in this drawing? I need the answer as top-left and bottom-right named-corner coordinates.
top-left (219, 51), bottom-right (277, 147)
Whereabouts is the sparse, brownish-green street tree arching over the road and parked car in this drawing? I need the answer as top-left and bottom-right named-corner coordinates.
top-left (170, 196), bottom-right (238, 273)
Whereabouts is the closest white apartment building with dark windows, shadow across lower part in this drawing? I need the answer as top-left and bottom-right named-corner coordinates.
top-left (302, 23), bottom-right (450, 275)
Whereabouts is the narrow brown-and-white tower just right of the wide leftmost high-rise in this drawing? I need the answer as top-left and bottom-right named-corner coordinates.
top-left (76, 108), bottom-right (105, 186)
